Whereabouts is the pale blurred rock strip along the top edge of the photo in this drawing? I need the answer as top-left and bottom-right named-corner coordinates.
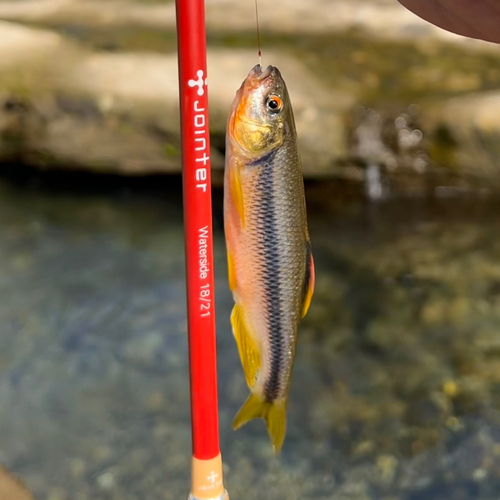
top-left (0, 0), bottom-right (495, 51)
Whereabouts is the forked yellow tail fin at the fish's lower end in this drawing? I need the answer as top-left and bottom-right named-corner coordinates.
top-left (233, 393), bottom-right (286, 453)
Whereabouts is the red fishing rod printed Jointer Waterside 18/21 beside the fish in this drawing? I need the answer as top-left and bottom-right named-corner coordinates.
top-left (176, 0), bottom-right (228, 500)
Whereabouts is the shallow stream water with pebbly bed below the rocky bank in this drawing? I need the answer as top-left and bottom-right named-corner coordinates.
top-left (0, 170), bottom-right (500, 500)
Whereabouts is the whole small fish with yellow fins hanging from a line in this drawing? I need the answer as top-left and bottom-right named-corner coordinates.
top-left (224, 64), bottom-right (315, 453)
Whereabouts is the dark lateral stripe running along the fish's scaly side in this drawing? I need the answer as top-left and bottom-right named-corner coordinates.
top-left (257, 156), bottom-right (285, 401)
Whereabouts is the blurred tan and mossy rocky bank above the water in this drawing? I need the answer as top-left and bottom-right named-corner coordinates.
top-left (0, 0), bottom-right (500, 188)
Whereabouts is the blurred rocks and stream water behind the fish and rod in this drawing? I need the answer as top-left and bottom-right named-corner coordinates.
top-left (0, 0), bottom-right (500, 500)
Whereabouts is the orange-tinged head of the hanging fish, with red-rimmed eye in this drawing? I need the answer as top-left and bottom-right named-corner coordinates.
top-left (228, 64), bottom-right (293, 157)
